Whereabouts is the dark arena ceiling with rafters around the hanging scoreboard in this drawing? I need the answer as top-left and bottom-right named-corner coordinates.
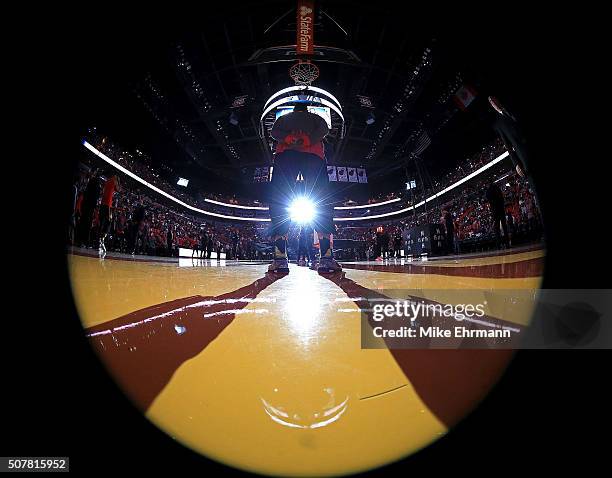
top-left (76, 1), bottom-right (524, 189)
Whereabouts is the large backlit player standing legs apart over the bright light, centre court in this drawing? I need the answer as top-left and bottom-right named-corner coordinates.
top-left (268, 103), bottom-right (342, 272)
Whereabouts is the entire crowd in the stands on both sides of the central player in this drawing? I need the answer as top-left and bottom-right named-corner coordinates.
top-left (70, 134), bottom-right (542, 259)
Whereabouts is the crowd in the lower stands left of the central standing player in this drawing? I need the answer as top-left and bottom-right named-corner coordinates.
top-left (70, 161), bottom-right (265, 259)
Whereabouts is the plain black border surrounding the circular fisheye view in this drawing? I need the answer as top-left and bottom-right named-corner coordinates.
top-left (0, 5), bottom-right (611, 474)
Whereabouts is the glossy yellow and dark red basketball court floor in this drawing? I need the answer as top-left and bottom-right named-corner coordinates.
top-left (68, 248), bottom-right (544, 475)
